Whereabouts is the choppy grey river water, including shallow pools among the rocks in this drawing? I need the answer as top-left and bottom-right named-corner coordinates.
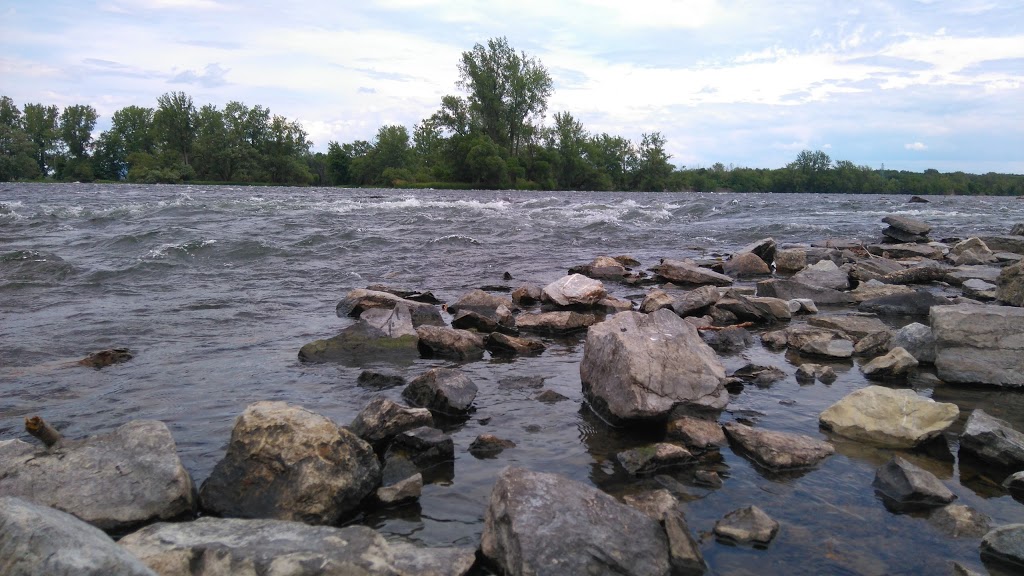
top-left (0, 184), bottom-right (1024, 574)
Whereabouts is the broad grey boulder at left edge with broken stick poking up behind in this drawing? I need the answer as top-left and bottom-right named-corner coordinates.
top-left (0, 420), bottom-right (196, 531)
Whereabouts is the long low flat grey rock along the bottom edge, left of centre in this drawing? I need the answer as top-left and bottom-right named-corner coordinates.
top-left (120, 518), bottom-right (475, 576)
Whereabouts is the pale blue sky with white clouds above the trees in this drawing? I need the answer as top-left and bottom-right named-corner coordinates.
top-left (0, 0), bottom-right (1024, 173)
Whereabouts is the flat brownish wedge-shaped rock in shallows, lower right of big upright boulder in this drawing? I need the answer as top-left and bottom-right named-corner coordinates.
top-left (725, 422), bottom-right (836, 469)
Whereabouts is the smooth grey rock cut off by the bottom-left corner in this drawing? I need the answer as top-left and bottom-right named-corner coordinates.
top-left (0, 497), bottom-right (156, 576)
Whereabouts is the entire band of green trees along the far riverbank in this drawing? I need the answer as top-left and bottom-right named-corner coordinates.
top-left (0, 37), bottom-right (1024, 196)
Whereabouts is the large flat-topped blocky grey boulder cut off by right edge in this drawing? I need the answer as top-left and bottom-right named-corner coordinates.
top-left (931, 304), bottom-right (1024, 387)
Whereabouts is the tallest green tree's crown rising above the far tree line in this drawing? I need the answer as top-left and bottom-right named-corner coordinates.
top-left (459, 37), bottom-right (552, 155)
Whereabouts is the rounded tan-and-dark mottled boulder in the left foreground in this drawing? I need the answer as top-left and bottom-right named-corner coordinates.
top-left (200, 402), bottom-right (381, 524)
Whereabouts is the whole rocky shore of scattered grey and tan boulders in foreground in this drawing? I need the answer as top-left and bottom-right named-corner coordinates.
top-left (0, 212), bottom-right (1024, 575)
